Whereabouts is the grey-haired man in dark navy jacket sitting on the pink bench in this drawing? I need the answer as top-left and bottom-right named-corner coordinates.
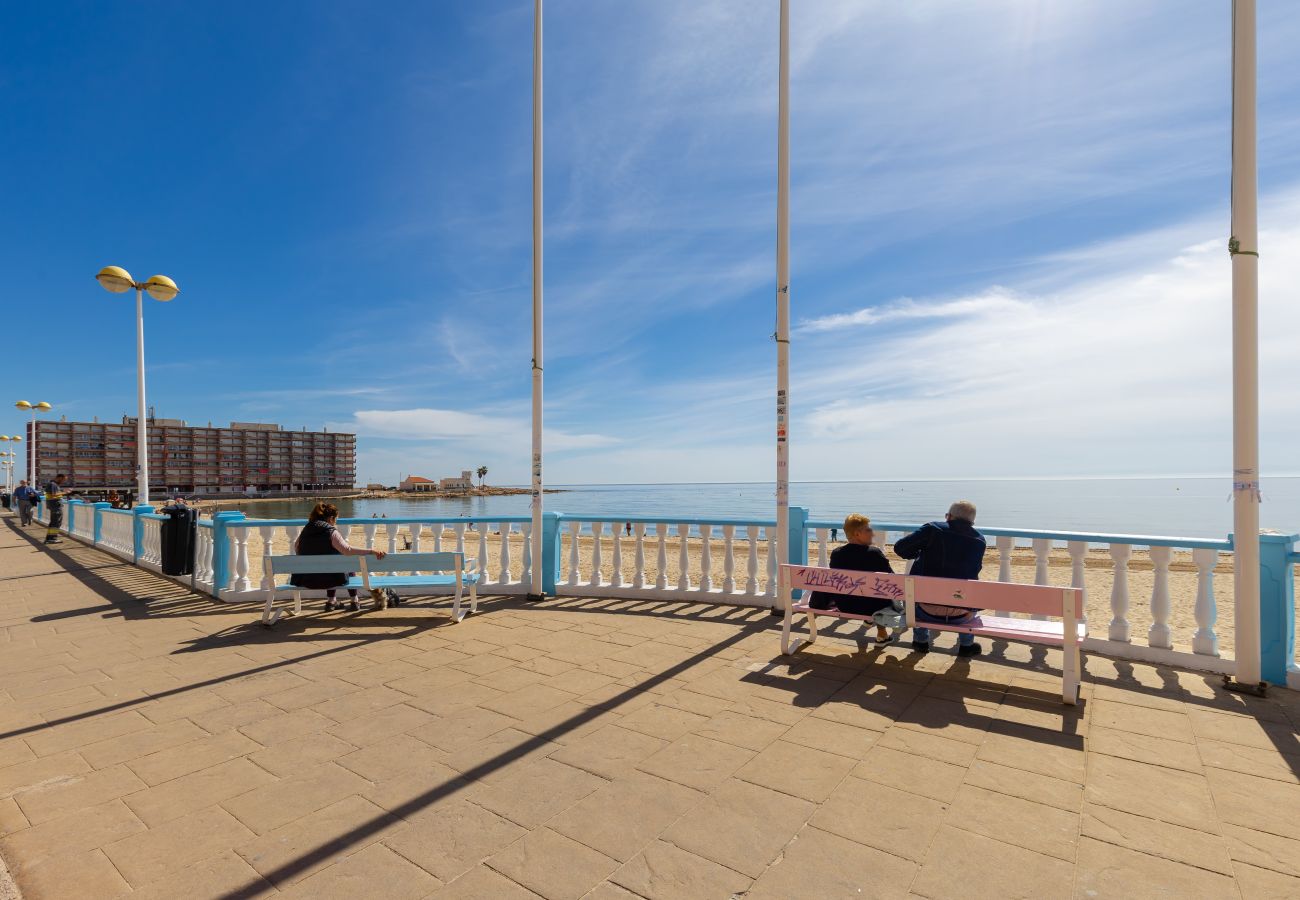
top-left (894, 499), bottom-right (987, 657)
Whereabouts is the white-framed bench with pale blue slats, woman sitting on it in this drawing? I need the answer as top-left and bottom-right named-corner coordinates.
top-left (261, 553), bottom-right (480, 627)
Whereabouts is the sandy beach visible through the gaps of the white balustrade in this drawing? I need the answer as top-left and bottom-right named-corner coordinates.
top-left (236, 523), bottom-right (1300, 657)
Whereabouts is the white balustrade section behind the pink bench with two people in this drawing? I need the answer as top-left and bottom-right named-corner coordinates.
top-left (807, 522), bottom-right (1232, 671)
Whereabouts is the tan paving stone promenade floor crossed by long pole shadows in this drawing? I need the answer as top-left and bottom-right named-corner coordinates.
top-left (0, 516), bottom-right (1300, 900)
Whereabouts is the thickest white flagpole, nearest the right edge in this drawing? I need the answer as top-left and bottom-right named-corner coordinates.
top-left (1229, 0), bottom-right (1264, 692)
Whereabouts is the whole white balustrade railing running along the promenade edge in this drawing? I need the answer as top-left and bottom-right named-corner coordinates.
top-left (15, 503), bottom-right (1284, 672)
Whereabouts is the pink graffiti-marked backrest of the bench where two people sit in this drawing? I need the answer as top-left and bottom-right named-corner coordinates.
top-left (781, 564), bottom-right (1083, 618)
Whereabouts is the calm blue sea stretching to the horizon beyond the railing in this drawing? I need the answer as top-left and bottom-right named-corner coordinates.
top-left (226, 477), bottom-right (1300, 538)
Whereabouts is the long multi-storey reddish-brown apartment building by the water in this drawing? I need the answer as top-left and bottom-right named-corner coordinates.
top-left (27, 416), bottom-right (356, 497)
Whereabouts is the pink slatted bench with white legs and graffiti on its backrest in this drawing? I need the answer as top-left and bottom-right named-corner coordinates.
top-left (779, 564), bottom-right (1088, 705)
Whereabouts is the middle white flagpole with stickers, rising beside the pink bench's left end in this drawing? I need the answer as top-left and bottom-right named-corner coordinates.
top-left (775, 0), bottom-right (790, 610)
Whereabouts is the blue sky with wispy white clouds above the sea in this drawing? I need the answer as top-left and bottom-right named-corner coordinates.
top-left (0, 0), bottom-right (1300, 484)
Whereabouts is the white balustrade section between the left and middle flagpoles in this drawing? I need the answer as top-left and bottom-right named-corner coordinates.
top-left (556, 514), bottom-right (776, 606)
